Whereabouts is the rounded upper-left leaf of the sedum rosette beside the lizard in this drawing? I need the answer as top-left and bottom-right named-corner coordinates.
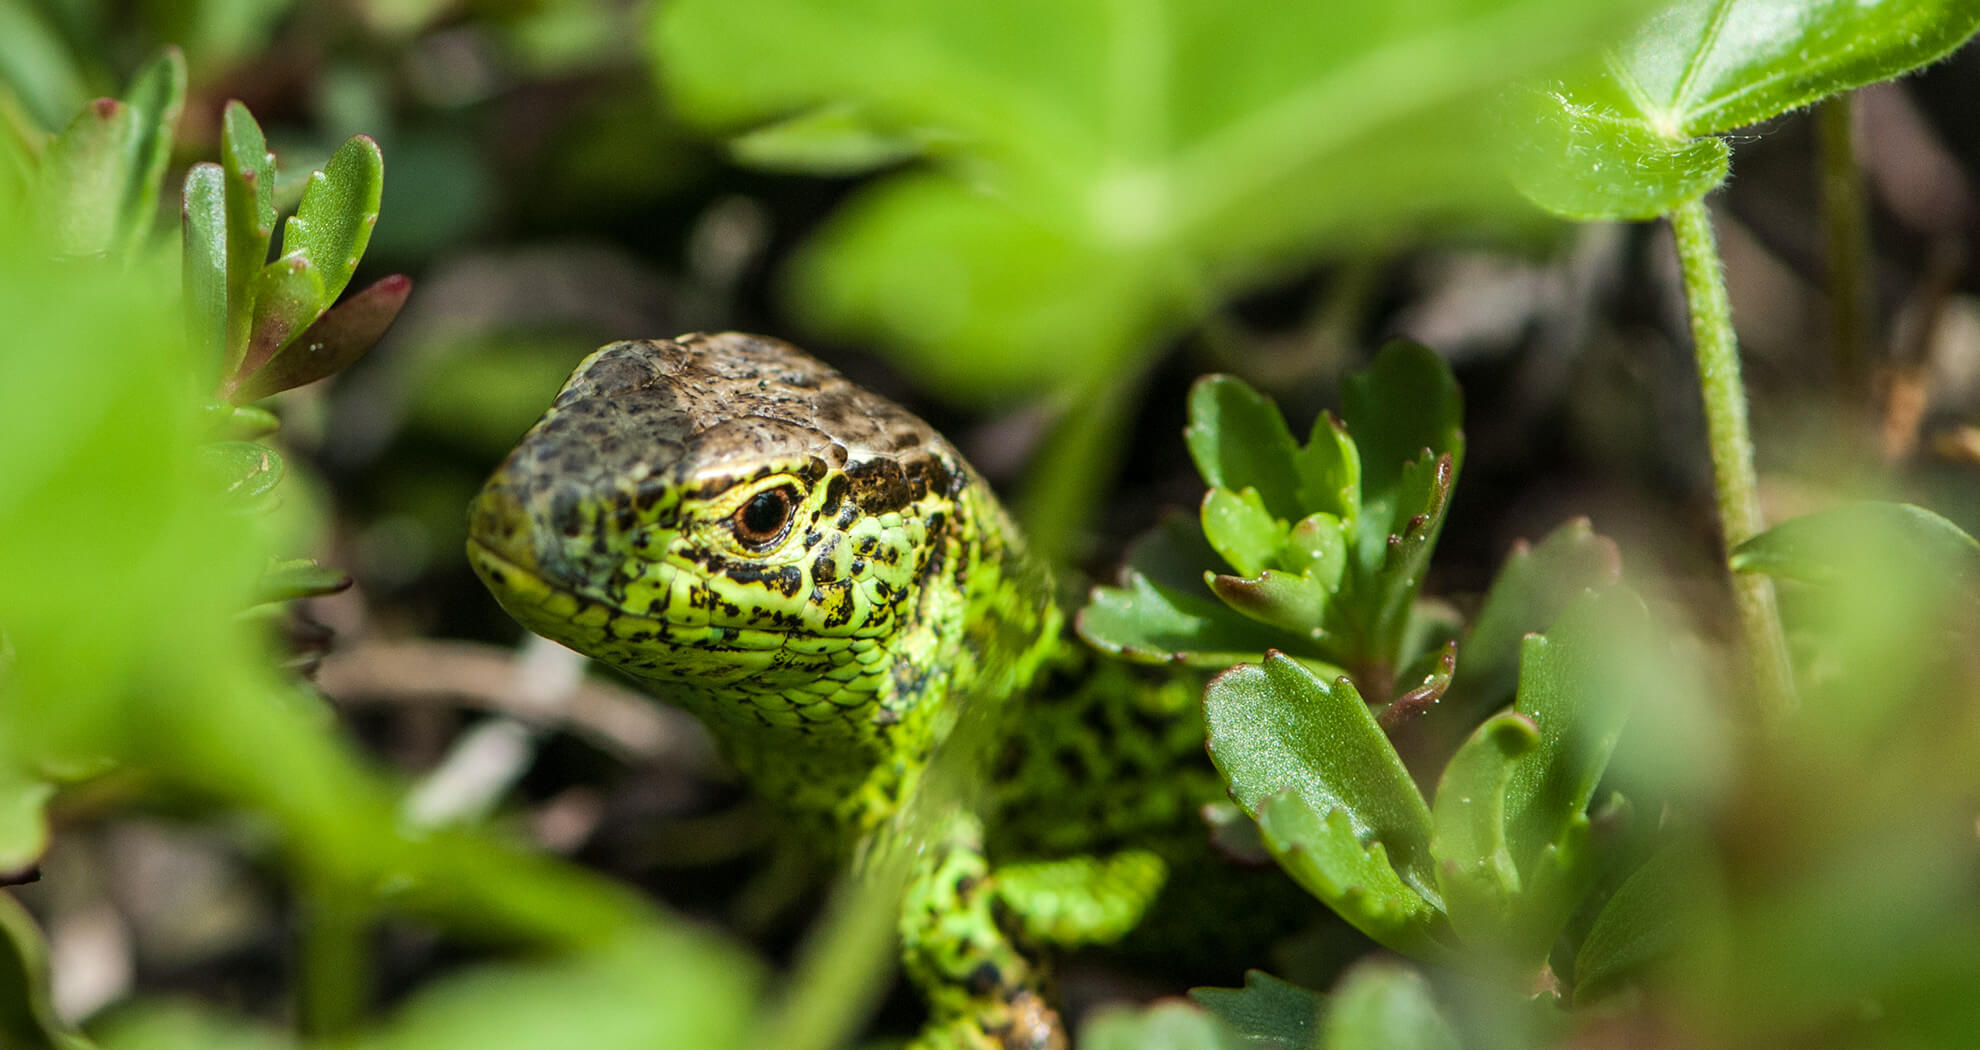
top-left (1182, 374), bottom-right (1329, 523)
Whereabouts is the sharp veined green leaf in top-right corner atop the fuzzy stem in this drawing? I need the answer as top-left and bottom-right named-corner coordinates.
top-left (1515, 0), bottom-right (1980, 220)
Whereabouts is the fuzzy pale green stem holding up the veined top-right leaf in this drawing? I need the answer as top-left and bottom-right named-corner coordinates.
top-left (1671, 200), bottom-right (1794, 721)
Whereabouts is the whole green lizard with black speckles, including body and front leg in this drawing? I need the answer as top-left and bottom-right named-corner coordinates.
top-left (467, 333), bottom-right (1251, 1050)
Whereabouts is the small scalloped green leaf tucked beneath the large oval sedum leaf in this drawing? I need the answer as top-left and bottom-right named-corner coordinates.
top-left (1257, 788), bottom-right (1451, 961)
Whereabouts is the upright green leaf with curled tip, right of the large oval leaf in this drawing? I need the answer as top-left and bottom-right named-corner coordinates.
top-left (1430, 711), bottom-right (1540, 946)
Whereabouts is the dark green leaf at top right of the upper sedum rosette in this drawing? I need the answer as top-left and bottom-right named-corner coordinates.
top-left (1340, 341), bottom-right (1465, 538)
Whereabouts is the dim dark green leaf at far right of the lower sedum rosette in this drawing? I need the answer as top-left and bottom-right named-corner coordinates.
top-left (1574, 840), bottom-right (1709, 1002)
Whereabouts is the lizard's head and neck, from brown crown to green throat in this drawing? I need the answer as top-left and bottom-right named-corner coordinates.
top-left (467, 333), bottom-right (1059, 824)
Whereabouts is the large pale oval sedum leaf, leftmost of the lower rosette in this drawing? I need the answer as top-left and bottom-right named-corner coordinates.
top-left (1204, 652), bottom-right (1436, 893)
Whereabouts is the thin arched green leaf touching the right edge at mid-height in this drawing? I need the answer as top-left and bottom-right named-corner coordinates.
top-left (1733, 501), bottom-right (1980, 584)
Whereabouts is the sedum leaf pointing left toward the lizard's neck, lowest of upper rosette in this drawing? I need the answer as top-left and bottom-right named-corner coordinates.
top-left (1075, 515), bottom-right (1305, 668)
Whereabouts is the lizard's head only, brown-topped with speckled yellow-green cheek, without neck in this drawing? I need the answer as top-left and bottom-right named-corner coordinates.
top-left (467, 333), bottom-right (980, 729)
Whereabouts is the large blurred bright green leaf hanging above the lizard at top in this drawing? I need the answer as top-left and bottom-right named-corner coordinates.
top-left (651, 0), bottom-right (1634, 400)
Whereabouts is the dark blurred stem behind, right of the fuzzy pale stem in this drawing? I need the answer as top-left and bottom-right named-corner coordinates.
top-left (1816, 95), bottom-right (1869, 394)
